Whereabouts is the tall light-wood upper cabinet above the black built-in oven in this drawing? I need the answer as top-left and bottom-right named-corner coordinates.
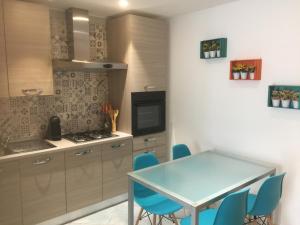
top-left (107, 14), bottom-right (168, 91)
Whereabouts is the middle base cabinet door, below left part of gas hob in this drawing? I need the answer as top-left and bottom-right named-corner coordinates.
top-left (65, 147), bottom-right (102, 212)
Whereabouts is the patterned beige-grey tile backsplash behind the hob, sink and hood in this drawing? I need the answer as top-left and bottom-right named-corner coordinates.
top-left (0, 10), bottom-right (108, 141)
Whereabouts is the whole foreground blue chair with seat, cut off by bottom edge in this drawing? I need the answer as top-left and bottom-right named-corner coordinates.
top-left (180, 190), bottom-right (249, 225)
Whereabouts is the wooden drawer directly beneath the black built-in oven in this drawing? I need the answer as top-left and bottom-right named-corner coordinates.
top-left (133, 133), bottom-right (167, 151)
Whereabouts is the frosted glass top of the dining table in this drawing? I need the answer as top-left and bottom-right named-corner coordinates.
top-left (128, 151), bottom-right (275, 207)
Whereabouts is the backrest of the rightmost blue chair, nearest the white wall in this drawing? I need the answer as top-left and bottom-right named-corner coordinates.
top-left (250, 173), bottom-right (285, 216)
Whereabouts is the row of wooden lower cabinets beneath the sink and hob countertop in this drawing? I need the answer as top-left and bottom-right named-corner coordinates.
top-left (0, 134), bottom-right (133, 225)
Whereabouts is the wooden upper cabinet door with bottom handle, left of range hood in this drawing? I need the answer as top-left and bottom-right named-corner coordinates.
top-left (4, 0), bottom-right (53, 96)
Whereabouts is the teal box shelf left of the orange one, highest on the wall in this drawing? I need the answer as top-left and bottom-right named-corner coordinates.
top-left (200, 38), bottom-right (227, 59)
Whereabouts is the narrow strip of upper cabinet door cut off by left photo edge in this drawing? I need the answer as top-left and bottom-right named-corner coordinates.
top-left (0, 0), bottom-right (8, 98)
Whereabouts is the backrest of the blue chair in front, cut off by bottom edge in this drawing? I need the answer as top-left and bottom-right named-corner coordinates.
top-left (214, 190), bottom-right (249, 225)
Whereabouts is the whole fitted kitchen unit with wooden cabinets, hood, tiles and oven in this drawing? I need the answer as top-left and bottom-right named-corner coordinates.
top-left (0, 0), bottom-right (168, 225)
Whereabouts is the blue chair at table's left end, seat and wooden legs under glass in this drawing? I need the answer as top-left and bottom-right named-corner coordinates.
top-left (133, 153), bottom-right (182, 225)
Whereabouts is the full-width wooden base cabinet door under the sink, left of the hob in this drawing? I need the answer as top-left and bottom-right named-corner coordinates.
top-left (20, 153), bottom-right (66, 225)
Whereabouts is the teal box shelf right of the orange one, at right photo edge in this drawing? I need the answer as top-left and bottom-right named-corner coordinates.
top-left (268, 85), bottom-right (300, 110)
